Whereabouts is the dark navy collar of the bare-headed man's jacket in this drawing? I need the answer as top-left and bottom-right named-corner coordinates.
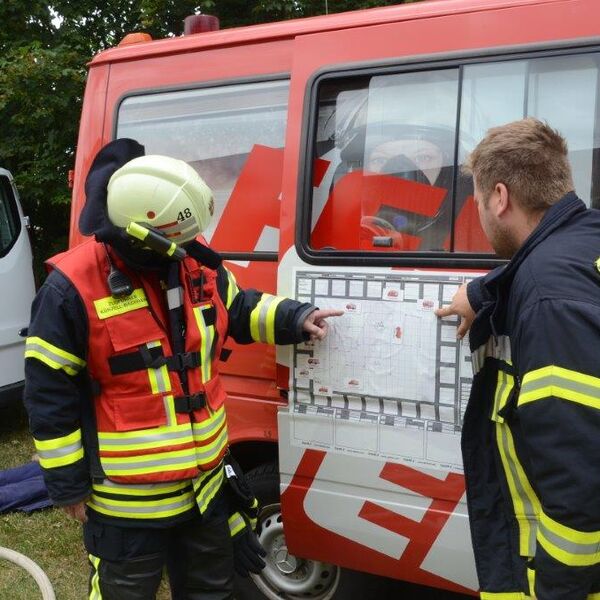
top-left (473, 192), bottom-right (587, 339)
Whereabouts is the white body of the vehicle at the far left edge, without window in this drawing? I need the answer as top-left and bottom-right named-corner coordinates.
top-left (0, 168), bottom-right (35, 404)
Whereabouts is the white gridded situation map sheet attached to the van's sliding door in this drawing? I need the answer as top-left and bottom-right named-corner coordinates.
top-left (290, 270), bottom-right (472, 470)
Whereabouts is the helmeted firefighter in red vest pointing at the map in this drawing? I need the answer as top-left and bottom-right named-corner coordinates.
top-left (25, 139), bottom-right (340, 600)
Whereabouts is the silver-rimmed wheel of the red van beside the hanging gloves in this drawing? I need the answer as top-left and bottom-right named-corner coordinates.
top-left (236, 463), bottom-right (384, 600)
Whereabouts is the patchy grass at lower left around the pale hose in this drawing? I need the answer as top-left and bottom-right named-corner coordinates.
top-left (0, 409), bottom-right (170, 600)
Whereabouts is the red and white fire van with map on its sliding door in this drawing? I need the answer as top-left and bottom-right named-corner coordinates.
top-left (70, 0), bottom-right (600, 600)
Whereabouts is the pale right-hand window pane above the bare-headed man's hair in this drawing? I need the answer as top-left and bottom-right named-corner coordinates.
top-left (457, 54), bottom-right (600, 221)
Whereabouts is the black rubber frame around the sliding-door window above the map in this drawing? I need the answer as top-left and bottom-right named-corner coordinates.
top-left (295, 39), bottom-right (600, 270)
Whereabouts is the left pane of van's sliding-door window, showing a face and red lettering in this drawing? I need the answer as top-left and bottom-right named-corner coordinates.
top-left (311, 69), bottom-right (468, 252)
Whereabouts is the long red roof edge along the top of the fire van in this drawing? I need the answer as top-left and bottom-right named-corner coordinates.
top-left (89, 0), bottom-right (565, 66)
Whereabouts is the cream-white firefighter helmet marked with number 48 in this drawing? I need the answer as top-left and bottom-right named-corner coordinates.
top-left (106, 155), bottom-right (214, 245)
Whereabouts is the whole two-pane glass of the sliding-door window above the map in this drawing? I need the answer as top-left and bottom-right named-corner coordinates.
top-left (309, 54), bottom-right (600, 255)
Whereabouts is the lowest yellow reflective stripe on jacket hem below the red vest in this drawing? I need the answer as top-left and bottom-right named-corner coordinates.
top-left (88, 487), bottom-right (194, 519)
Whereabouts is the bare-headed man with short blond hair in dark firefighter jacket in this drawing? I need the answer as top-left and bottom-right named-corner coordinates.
top-left (438, 118), bottom-right (600, 600)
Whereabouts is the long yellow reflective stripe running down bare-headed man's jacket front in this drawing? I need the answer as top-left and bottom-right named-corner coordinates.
top-left (496, 423), bottom-right (540, 557)
